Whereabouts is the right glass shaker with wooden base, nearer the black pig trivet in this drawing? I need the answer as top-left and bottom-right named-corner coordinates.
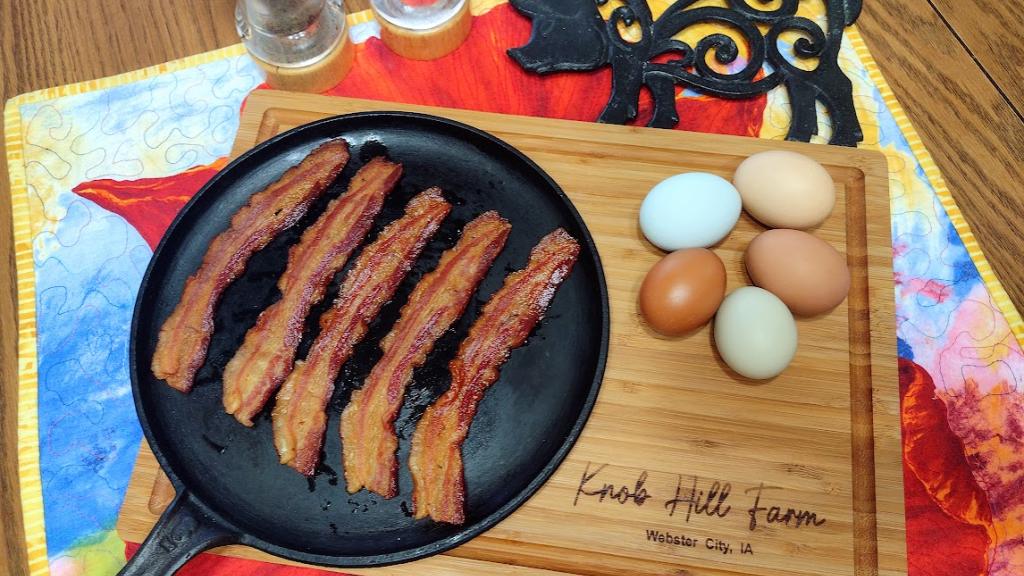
top-left (370, 0), bottom-right (473, 60)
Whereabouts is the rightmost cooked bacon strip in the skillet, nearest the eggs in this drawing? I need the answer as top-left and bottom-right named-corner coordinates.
top-left (409, 229), bottom-right (580, 524)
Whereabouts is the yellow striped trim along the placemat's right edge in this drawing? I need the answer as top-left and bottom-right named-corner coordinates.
top-left (847, 26), bottom-right (1024, 345)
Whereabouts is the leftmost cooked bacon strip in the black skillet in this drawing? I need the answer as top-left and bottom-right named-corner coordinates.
top-left (153, 138), bottom-right (348, 393)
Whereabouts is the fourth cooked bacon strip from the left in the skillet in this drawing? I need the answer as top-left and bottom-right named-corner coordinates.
top-left (341, 211), bottom-right (512, 498)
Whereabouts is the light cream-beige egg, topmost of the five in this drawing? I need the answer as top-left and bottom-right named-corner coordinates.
top-left (732, 150), bottom-right (836, 230)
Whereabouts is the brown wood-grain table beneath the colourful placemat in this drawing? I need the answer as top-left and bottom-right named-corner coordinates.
top-left (0, 0), bottom-right (1024, 574)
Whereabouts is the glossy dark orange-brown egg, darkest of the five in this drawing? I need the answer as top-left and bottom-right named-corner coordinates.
top-left (640, 243), bottom-right (725, 336)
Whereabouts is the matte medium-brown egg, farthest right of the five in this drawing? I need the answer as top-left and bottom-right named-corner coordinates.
top-left (743, 229), bottom-right (850, 316)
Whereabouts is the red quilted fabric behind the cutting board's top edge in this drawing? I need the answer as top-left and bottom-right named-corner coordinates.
top-left (326, 4), bottom-right (767, 136)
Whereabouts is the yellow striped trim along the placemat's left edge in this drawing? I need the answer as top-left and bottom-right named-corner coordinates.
top-left (3, 98), bottom-right (50, 576)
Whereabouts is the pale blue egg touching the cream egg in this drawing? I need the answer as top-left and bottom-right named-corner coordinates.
top-left (640, 172), bottom-right (741, 252)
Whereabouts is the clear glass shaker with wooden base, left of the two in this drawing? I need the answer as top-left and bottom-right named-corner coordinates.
top-left (234, 0), bottom-right (354, 92)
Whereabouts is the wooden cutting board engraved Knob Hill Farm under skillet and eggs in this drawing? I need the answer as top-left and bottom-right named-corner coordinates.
top-left (118, 91), bottom-right (906, 576)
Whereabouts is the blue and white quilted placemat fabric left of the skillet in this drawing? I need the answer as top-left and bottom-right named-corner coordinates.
top-left (19, 56), bottom-right (262, 559)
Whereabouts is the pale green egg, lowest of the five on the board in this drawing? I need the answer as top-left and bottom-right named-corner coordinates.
top-left (715, 286), bottom-right (797, 380)
